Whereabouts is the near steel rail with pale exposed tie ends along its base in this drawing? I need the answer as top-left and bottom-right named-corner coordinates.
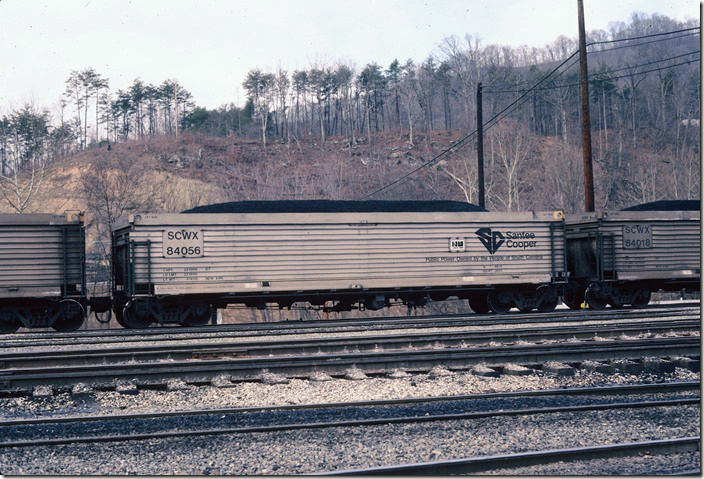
top-left (0, 337), bottom-right (701, 391)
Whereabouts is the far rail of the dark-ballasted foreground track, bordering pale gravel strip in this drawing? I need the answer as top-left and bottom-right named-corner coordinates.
top-left (0, 381), bottom-right (701, 428)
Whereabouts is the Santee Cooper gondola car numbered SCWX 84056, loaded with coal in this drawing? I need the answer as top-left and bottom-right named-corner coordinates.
top-left (113, 202), bottom-right (566, 328)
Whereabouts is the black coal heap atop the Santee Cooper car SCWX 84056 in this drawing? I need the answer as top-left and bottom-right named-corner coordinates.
top-left (183, 200), bottom-right (487, 213)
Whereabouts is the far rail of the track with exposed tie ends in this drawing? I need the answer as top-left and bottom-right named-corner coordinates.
top-left (0, 319), bottom-right (701, 369)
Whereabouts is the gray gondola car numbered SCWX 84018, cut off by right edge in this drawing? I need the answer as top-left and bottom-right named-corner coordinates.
top-left (564, 202), bottom-right (701, 309)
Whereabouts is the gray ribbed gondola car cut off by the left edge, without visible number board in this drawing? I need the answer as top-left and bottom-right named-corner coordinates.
top-left (0, 212), bottom-right (86, 333)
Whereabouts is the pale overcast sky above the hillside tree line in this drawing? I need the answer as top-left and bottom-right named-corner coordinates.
top-left (0, 0), bottom-right (699, 114)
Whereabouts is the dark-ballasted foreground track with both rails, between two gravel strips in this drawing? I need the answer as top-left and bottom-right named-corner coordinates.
top-left (0, 382), bottom-right (700, 450)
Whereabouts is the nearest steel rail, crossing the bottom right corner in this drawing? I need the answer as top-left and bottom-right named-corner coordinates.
top-left (320, 436), bottom-right (701, 476)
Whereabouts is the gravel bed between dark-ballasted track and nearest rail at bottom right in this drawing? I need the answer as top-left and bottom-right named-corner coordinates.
top-left (0, 406), bottom-right (700, 475)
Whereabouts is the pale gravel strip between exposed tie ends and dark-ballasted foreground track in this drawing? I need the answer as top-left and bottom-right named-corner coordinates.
top-left (0, 368), bottom-right (699, 418)
